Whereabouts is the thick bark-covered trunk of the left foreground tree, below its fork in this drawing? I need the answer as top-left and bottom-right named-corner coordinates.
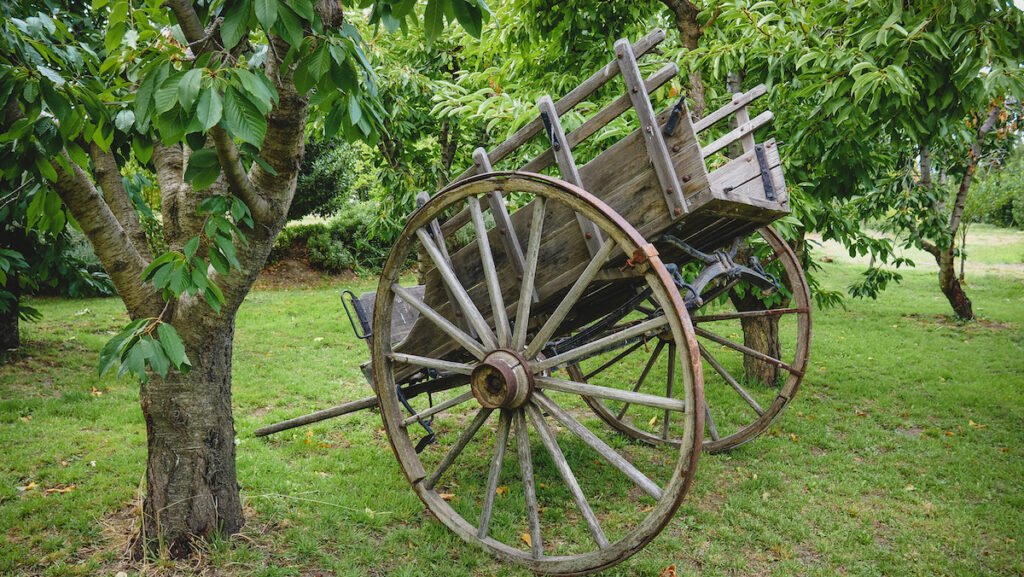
top-left (136, 315), bottom-right (244, 559)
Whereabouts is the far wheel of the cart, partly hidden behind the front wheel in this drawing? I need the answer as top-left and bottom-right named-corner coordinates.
top-left (568, 226), bottom-right (811, 452)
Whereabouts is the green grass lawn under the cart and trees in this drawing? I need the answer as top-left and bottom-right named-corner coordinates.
top-left (0, 229), bottom-right (1024, 576)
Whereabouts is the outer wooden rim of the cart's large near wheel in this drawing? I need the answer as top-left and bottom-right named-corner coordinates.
top-left (372, 172), bottom-right (703, 575)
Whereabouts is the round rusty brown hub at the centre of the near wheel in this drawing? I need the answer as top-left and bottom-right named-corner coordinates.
top-left (469, 348), bottom-right (534, 409)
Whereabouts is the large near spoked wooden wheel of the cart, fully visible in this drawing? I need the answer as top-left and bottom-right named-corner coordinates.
top-left (373, 172), bottom-right (703, 575)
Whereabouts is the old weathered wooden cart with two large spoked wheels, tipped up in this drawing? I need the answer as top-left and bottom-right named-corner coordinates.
top-left (259, 31), bottom-right (810, 574)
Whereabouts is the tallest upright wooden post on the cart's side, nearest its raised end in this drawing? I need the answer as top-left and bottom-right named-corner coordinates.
top-left (615, 40), bottom-right (689, 216)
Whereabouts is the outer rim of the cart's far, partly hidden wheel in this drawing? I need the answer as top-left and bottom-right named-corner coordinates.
top-left (568, 226), bottom-right (811, 453)
